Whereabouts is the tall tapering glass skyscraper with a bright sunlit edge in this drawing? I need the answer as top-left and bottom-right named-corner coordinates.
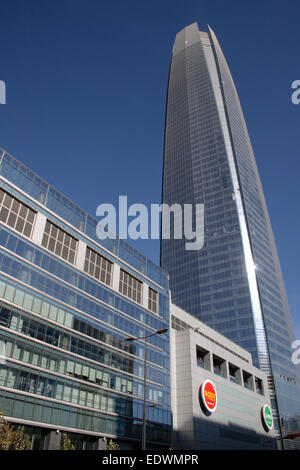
top-left (161, 23), bottom-right (300, 435)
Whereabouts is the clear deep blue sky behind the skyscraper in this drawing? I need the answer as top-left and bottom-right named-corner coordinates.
top-left (0, 0), bottom-right (300, 339)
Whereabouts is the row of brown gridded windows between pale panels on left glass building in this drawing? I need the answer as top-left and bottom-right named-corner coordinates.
top-left (0, 189), bottom-right (158, 313)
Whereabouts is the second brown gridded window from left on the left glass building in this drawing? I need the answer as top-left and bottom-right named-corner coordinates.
top-left (42, 220), bottom-right (78, 264)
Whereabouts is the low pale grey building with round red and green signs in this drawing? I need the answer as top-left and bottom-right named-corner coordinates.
top-left (170, 303), bottom-right (276, 450)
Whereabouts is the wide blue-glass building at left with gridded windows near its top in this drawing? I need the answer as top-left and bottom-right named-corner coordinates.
top-left (0, 150), bottom-right (171, 448)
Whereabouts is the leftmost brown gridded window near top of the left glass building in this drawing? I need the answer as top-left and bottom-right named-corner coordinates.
top-left (0, 189), bottom-right (36, 237)
